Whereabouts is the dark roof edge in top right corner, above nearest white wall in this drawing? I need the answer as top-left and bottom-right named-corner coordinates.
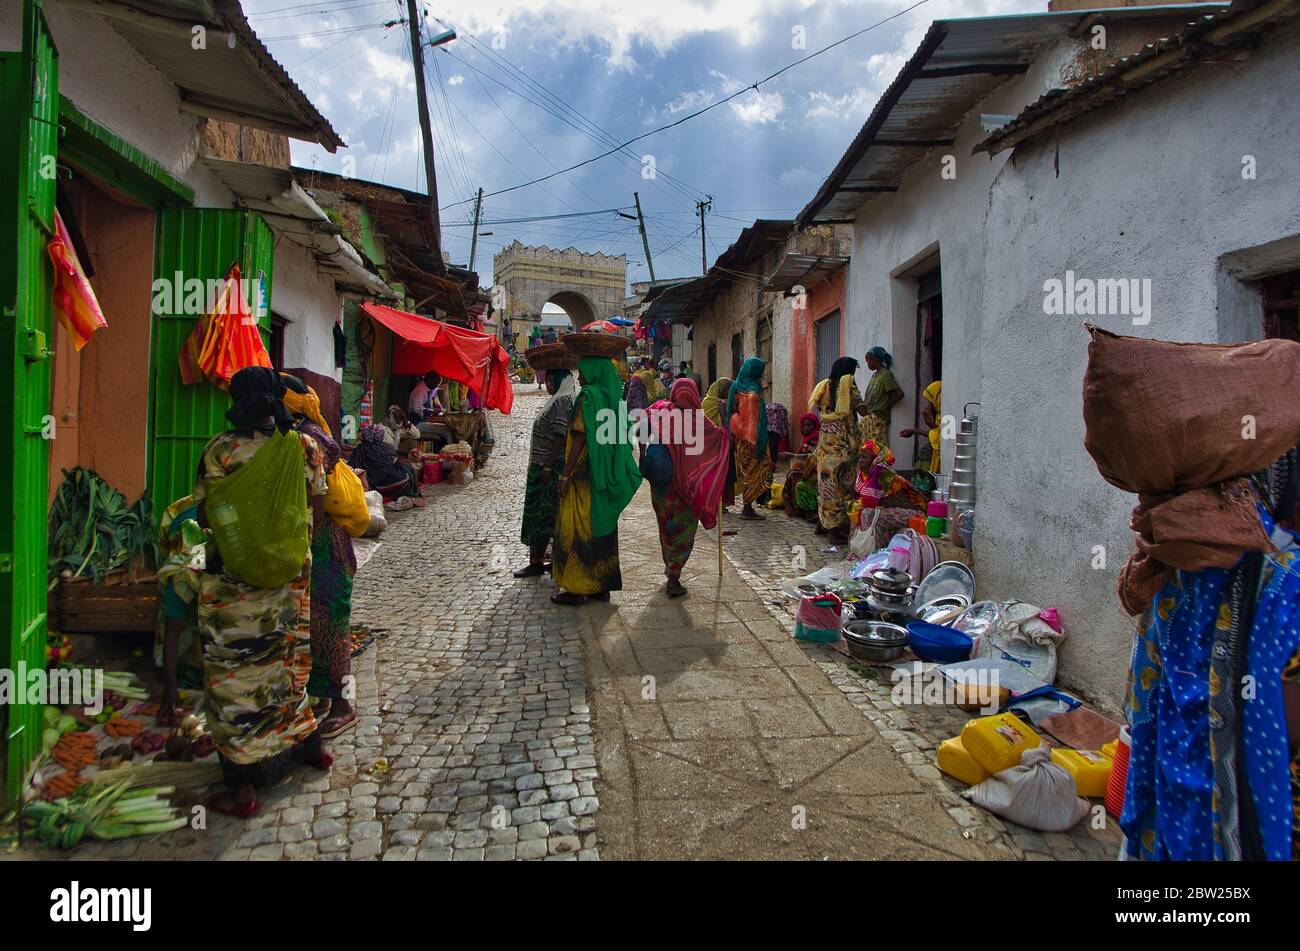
top-left (975, 0), bottom-right (1300, 152)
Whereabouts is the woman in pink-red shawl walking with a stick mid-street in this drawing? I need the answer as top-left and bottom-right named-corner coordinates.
top-left (650, 377), bottom-right (729, 598)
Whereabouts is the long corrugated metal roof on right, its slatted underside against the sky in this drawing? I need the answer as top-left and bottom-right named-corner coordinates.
top-left (796, 4), bottom-right (1226, 229)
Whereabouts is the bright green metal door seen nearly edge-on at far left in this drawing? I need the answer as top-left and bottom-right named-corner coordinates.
top-left (0, 0), bottom-right (59, 799)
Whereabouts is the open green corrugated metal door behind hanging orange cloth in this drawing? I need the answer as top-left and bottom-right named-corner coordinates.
top-left (150, 208), bottom-right (274, 514)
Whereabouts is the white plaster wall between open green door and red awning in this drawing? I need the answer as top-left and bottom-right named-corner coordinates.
top-left (270, 239), bottom-right (343, 378)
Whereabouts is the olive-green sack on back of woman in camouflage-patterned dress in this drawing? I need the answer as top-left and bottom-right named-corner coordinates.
top-left (204, 430), bottom-right (311, 587)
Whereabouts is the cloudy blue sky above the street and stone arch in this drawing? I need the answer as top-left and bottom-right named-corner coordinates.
top-left (243, 0), bottom-right (1047, 293)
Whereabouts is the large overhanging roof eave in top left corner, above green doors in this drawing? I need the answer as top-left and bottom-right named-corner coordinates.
top-left (62, 0), bottom-right (345, 152)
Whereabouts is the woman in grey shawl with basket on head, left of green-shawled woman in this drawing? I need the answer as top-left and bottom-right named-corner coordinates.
top-left (515, 343), bottom-right (577, 578)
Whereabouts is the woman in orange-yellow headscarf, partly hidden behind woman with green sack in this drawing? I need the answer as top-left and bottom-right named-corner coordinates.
top-left (281, 373), bottom-right (356, 739)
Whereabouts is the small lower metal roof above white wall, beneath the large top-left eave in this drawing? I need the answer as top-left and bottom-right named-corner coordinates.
top-left (202, 159), bottom-right (402, 300)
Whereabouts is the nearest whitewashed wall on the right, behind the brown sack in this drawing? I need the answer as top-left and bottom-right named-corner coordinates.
top-left (977, 18), bottom-right (1300, 708)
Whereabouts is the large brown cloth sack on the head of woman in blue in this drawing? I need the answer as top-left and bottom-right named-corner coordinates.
top-left (1083, 326), bottom-right (1300, 615)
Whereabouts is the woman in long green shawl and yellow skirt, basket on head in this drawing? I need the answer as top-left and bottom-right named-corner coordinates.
top-left (551, 334), bottom-right (641, 604)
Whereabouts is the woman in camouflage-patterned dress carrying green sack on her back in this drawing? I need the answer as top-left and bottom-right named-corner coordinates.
top-left (192, 366), bottom-right (333, 818)
